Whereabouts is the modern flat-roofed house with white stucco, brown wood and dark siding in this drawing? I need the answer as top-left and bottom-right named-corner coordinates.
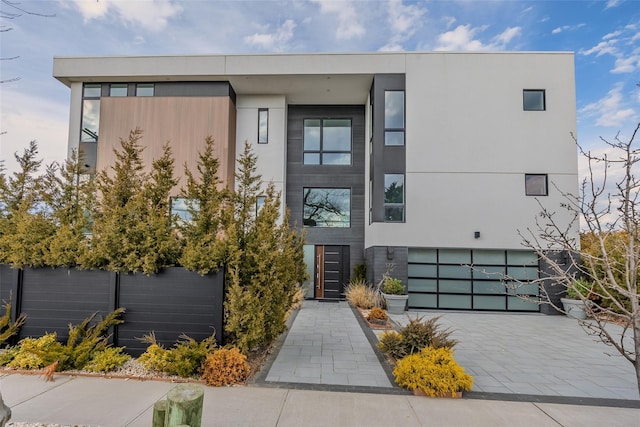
top-left (53, 52), bottom-right (578, 311)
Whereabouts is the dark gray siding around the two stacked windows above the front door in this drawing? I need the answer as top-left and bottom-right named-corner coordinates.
top-left (286, 105), bottom-right (366, 271)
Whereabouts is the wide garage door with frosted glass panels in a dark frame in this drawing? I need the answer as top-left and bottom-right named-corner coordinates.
top-left (408, 248), bottom-right (540, 311)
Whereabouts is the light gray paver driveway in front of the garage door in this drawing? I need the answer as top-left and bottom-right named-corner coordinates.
top-left (390, 311), bottom-right (640, 402)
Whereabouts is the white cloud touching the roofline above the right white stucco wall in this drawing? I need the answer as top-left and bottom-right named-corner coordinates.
top-left (435, 24), bottom-right (522, 51)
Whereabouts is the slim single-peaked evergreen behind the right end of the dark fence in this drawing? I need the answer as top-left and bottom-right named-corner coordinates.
top-left (177, 136), bottom-right (229, 274)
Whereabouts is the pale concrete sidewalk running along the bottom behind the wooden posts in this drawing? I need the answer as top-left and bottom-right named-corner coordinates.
top-left (0, 374), bottom-right (640, 427)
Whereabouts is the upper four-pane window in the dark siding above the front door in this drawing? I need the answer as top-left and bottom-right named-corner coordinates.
top-left (303, 119), bottom-right (351, 165)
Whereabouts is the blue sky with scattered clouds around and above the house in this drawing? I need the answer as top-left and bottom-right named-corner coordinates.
top-left (0, 0), bottom-right (640, 176)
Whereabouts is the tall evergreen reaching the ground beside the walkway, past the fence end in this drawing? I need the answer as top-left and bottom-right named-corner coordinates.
top-left (225, 144), bottom-right (305, 352)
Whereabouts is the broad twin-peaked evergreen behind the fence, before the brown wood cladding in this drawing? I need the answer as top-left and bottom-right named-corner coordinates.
top-left (86, 129), bottom-right (180, 274)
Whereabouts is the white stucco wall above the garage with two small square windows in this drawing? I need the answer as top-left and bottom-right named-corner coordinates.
top-left (365, 53), bottom-right (578, 249)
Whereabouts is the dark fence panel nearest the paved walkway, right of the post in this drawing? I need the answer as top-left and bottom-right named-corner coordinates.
top-left (117, 268), bottom-right (224, 356)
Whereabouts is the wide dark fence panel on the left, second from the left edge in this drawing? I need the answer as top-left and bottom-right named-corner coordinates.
top-left (20, 267), bottom-right (113, 341)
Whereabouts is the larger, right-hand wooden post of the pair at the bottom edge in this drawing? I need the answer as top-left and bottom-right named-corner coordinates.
top-left (164, 384), bottom-right (204, 427)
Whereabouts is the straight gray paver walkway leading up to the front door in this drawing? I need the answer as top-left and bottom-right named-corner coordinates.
top-left (266, 301), bottom-right (393, 388)
